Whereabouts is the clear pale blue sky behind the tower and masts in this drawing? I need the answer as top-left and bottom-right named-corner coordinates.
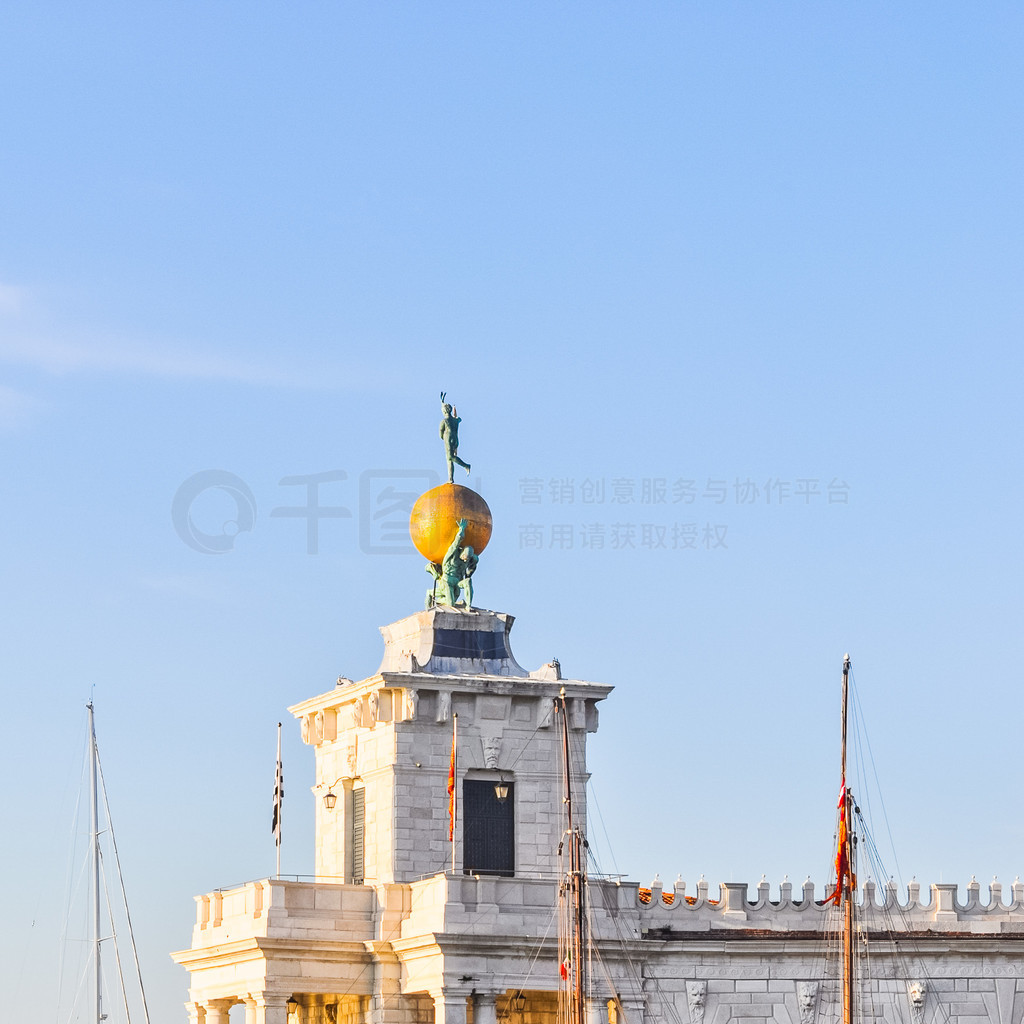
top-left (0, 0), bottom-right (1024, 1024)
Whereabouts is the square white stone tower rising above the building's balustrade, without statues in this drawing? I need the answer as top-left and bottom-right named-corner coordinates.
top-left (289, 606), bottom-right (610, 885)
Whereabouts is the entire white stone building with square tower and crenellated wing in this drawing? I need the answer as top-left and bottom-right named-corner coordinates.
top-left (174, 608), bottom-right (1024, 1024)
